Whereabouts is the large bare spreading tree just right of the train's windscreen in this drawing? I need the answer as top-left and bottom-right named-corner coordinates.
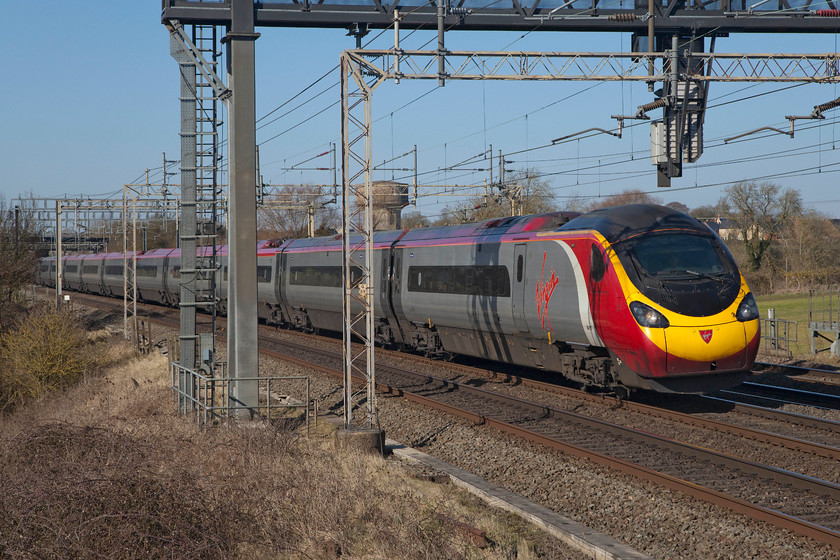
top-left (718, 181), bottom-right (802, 270)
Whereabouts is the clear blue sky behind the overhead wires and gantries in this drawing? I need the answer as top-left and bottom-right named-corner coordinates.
top-left (0, 0), bottom-right (840, 217)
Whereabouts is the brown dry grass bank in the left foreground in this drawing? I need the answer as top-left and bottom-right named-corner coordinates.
top-left (0, 308), bottom-right (562, 560)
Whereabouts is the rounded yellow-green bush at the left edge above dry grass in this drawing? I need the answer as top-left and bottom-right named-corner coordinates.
top-left (0, 307), bottom-right (91, 411)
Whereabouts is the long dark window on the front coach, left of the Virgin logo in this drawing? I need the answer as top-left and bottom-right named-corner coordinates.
top-left (408, 266), bottom-right (510, 297)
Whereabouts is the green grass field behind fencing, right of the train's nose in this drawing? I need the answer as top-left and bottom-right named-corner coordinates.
top-left (755, 292), bottom-right (840, 365)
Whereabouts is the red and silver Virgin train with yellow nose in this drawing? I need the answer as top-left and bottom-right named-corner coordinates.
top-left (40, 204), bottom-right (759, 396)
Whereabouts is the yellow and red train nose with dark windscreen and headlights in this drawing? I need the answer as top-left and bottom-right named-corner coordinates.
top-left (593, 214), bottom-right (759, 393)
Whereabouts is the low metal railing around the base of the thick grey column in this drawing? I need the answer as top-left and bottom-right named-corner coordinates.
top-left (170, 362), bottom-right (317, 430)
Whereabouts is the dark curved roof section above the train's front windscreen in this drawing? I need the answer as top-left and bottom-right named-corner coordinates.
top-left (559, 204), bottom-right (712, 243)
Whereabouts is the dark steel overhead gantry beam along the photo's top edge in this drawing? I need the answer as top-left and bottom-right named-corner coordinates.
top-left (163, 0), bottom-right (840, 33)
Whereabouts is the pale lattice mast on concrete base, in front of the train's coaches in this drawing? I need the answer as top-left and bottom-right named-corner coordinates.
top-left (341, 56), bottom-right (382, 429)
